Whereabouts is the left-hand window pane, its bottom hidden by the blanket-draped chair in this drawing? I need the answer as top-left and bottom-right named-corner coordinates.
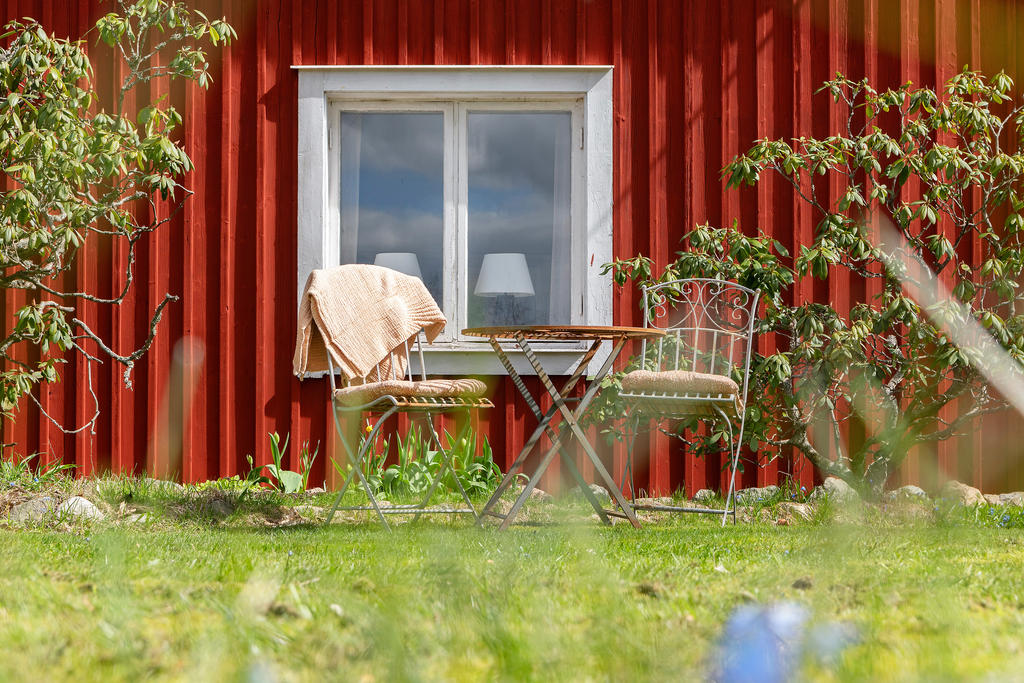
top-left (341, 112), bottom-right (445, 304)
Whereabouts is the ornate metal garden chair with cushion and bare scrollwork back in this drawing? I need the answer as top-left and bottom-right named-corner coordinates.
top-left (620, 278), bottom-right (760, 525)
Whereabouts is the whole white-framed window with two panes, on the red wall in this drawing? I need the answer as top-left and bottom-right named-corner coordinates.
top-left (296, 67), bottom-right (611, 372)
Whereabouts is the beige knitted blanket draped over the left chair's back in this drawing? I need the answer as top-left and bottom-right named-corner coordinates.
top-left (292, 264), bottom-right (446, 381)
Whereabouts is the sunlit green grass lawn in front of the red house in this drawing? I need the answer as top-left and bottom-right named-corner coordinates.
top-left (0, 505), bottom-right (1024, 681)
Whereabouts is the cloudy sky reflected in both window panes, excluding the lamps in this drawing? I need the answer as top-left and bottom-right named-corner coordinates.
top-left (341, 112), bottom-right (569, 325)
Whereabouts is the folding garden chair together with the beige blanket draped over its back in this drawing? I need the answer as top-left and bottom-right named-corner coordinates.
top-left (293, 264), bottom-right (492, 526)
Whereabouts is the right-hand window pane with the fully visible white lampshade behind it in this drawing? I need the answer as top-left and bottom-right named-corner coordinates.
top-left (467, 112), bottom-right (571, 327)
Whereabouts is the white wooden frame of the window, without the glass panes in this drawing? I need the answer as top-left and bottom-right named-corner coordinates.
top-left (293, 66), bottom-right (612, 374)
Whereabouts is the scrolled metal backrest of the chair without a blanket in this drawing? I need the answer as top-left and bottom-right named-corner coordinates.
top-left (641, 278), bottom-right (760, 398)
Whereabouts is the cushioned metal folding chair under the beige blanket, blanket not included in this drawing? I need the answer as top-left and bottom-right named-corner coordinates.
top-left (327, 331), bottom-right (494, 527)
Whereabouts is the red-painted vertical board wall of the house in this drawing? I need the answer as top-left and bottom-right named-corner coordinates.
top-left (0, 0), bottom-right (1024, 493)
